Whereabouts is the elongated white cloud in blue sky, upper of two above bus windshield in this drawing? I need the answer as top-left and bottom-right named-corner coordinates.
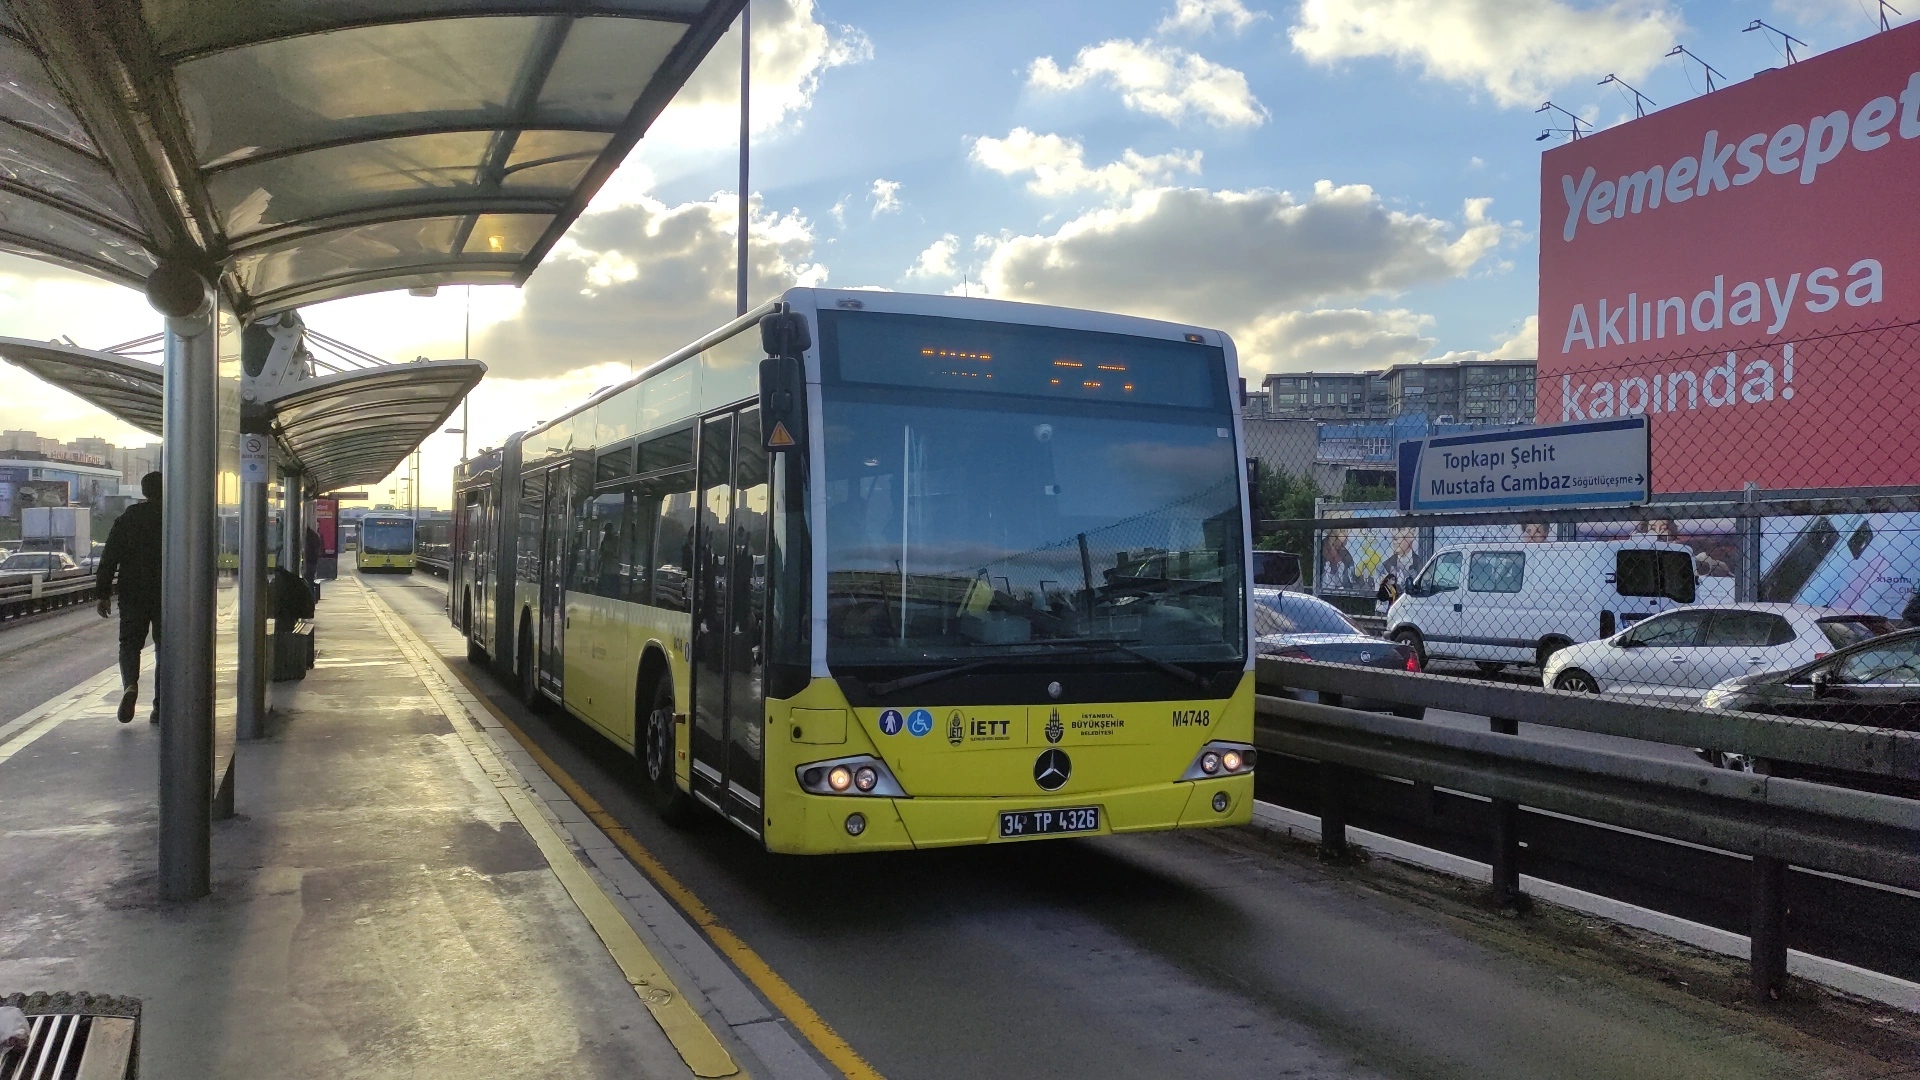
top-left (1027, 38), bottom-right (1267, 127)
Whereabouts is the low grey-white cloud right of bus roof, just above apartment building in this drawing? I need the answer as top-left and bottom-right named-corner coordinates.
top-left (1233, 307), bottom-right (1434, 374)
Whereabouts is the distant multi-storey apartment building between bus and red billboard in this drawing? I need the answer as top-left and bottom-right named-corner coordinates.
top-left (1246, 359), bottom-right (1536, 427)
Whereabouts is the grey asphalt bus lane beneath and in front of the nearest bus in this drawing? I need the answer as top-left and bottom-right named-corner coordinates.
top-left (365, 577), bottom-right (1870, 1080)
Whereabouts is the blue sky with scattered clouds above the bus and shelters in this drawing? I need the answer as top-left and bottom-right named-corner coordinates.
top-left (0, 0), bottom-right (1896, 505)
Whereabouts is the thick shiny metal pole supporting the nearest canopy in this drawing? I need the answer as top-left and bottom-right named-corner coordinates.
top-left (148, 263), bottom-right (219, 899)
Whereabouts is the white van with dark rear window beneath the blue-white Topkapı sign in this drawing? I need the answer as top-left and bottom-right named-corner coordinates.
top-left (1386, 538), bottom-right (1695, 671)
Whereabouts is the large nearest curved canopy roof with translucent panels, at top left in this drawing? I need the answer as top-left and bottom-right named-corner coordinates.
top-left (0, 0), bottom-right (745, 319)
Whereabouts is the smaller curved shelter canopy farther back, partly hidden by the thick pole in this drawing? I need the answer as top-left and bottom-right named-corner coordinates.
top-left (0, 338), bottom-right (486, 492)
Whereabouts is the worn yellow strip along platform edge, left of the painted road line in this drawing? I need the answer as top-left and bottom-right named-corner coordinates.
top-left (361, 588), bottom-right (745, 1076)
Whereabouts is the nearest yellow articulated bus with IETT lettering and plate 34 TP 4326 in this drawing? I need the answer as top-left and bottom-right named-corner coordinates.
top-left (449, 288), bottom-right (1254, 853)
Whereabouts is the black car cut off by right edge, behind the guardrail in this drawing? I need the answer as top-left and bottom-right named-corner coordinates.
top-left (1699, 628), bottom-right (1920, 798)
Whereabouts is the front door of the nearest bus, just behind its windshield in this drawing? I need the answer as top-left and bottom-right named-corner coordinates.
top-left (693, 407), bottom-right (768, 822)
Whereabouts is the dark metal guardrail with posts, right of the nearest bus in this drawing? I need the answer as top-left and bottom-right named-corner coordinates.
top-left (1254, 659), bottom-right (1920, 1001)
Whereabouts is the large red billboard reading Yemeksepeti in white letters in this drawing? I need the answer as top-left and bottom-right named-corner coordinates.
top-left (1536, 23), bottom-right (1920, 492)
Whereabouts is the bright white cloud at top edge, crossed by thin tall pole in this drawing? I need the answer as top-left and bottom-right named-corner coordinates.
top-left (647, 0), bottom-right (874, 146)
